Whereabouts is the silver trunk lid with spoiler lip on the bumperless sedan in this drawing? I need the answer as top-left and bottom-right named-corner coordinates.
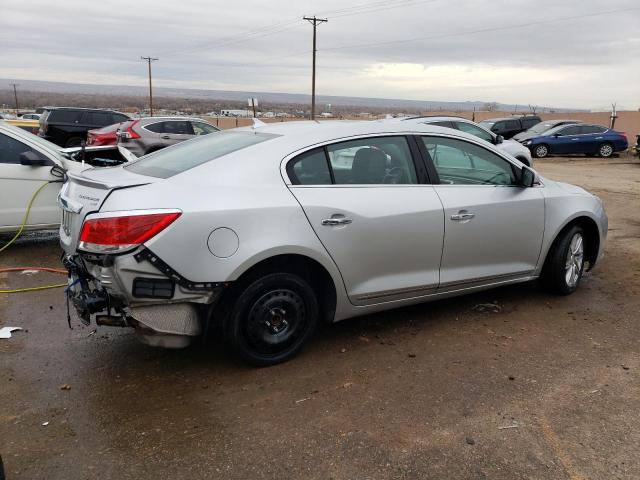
top-left (58, 167), bottom-right (160, 254)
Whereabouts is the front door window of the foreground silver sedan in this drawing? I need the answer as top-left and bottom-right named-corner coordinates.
top-left (421, 137), bottom-right (517, 185)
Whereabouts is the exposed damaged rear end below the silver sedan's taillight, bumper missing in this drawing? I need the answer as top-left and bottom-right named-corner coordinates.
top-left (63, 249), bottom-right (226, 348)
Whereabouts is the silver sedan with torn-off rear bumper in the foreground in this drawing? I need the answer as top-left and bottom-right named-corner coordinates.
top-left (59, 121), bottom-right (607, 365)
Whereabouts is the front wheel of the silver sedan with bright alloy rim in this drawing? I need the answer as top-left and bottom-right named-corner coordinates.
top-left (542, 225), bottom-right (585, 295)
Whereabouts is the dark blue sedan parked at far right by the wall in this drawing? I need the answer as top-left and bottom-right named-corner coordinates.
top-left (522, 124), bottom-right (629, 158)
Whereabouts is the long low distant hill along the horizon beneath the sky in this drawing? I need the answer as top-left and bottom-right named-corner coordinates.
top-left (0, 79), bottom-right (580, 112)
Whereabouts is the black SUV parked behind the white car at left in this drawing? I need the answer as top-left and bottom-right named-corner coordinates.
top-left (38, 107), bottom-right (130, 147)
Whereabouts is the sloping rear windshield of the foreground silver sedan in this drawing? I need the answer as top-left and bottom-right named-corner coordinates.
top-left (124, 132), bottom-right (277, 178)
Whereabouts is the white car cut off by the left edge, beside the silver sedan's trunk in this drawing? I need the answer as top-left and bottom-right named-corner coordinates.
top-left (0, 121), bottom-right (127, 232)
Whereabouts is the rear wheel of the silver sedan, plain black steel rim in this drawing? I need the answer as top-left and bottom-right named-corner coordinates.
top-left (225, 273), bottom-right (319, 367)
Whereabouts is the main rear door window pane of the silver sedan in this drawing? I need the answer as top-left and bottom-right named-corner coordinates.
top-left (327, 137), bottom-right (418, 185)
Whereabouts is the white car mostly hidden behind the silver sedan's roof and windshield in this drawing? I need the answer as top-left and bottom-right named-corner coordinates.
top-left (390, 116), bottom-right (533, 167)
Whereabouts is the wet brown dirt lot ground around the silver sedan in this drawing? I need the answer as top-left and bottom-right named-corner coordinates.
top-left (0, 157), bottom-right (640, 480)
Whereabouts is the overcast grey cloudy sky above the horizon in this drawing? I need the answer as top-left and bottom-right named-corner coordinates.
top-left (0, 0), bottom-right (640, 109)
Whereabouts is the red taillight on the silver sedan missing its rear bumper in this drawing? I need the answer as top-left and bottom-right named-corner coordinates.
top-left (78, 210), bottom-right (182, 253)
